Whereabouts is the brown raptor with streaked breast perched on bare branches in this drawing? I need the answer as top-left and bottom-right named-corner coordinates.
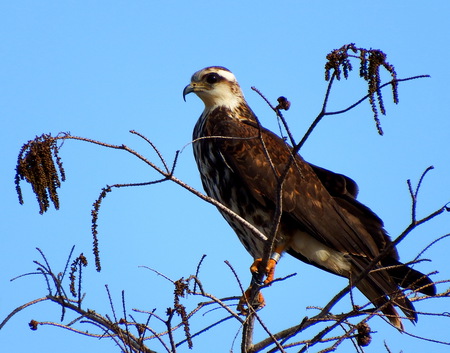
top-left (183, 66), bottom-right (436, 330)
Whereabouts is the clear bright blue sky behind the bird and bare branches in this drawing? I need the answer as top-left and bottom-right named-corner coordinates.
top-left (0, 0), bottom-right (450, 353)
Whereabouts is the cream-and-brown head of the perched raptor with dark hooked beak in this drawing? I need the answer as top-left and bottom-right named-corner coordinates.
top-left (183, 66), bottom-right (244, 110)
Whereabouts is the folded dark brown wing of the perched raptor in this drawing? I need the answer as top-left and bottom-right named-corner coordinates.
top-left (207, 116), bottom-right (385, 258)
